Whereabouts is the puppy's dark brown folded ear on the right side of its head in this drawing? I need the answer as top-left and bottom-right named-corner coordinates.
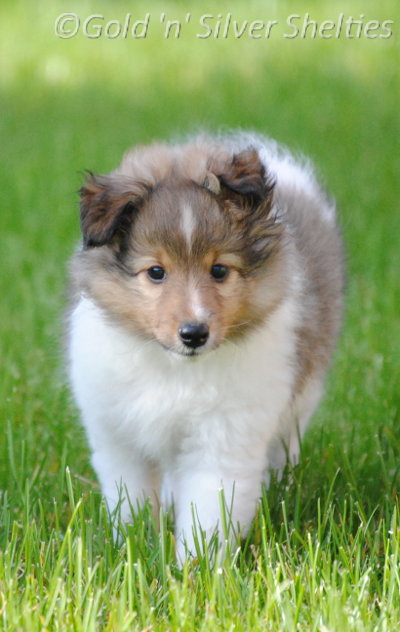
top-left (217, 149), bottom-right (273, 204)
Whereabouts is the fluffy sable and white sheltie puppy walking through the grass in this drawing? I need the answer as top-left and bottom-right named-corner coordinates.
top-left (69, 132), bottom-right (343, 555)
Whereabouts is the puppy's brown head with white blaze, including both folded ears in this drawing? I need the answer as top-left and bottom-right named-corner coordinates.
top-left (75, 146), bottom-right (282, 356)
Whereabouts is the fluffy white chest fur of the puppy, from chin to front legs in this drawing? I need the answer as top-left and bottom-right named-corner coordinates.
top-left (70, 298), bottom-right (294, 462)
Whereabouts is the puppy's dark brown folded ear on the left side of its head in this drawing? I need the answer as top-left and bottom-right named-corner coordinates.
top-left (80, 174), bottom-right (149, 248)
